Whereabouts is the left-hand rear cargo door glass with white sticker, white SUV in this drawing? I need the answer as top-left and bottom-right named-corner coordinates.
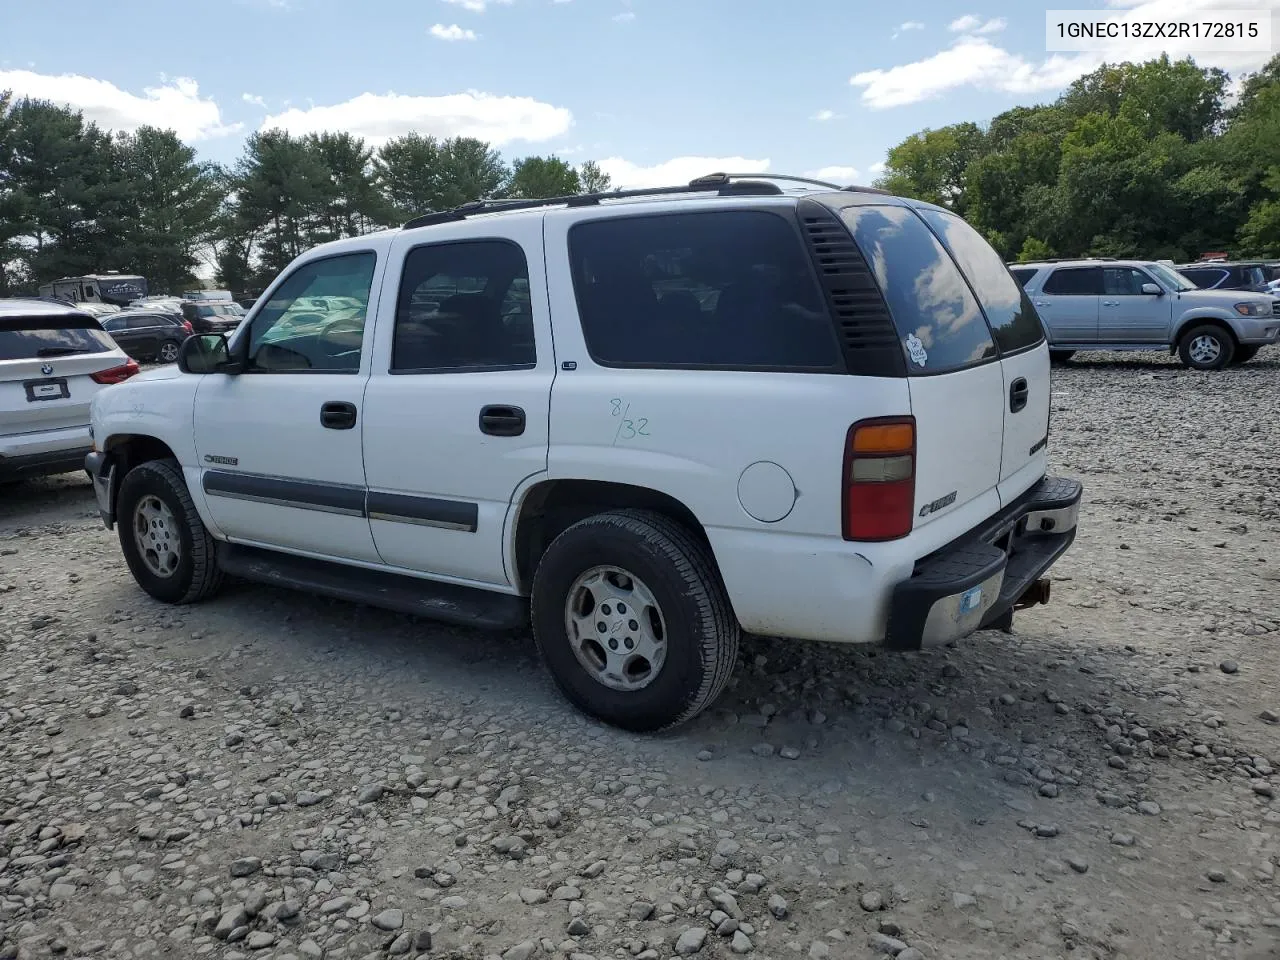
top-left (841, 205), bottom-right (1011, 374)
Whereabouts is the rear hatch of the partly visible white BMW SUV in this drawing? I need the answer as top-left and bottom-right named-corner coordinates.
top-left (0, 315), bottom-right (124, 435)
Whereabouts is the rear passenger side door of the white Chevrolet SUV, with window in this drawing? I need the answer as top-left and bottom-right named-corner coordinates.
top-left (365, 218), bottom-right (556, 586)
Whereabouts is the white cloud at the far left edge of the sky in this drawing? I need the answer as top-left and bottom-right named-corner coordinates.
top-left (0, 70), bottom-right (241, 141)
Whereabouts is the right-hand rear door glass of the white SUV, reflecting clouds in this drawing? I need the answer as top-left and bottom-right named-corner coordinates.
top-left (919, 210), bottom-right (1044, 353)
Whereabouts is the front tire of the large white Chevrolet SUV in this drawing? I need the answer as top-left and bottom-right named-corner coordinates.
top-left (115, 460), bottom-right (223, 604)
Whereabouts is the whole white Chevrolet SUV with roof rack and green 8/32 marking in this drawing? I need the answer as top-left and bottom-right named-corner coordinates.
top-left (87, 174), bottom-right (1080, 730)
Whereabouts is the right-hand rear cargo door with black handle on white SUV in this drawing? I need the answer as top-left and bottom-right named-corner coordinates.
top-left (920, 209), bottom-right (1050, 503)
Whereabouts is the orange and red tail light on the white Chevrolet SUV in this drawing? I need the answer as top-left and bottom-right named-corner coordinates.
top-left (844, 417), bottom-right (915, 540)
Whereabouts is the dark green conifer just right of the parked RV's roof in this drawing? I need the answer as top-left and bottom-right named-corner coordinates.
top-left (116, 127), bottom-right (223, 292)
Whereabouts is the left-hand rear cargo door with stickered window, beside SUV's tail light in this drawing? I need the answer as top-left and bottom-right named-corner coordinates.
top-left (841, 204), bottom-right (1016, 529)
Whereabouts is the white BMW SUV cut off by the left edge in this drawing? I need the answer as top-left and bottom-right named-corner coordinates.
top-left (0, 300), bottom-right (138, 484)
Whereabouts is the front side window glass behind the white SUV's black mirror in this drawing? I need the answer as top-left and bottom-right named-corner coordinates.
top-left (245, 253), bottom-right (378, 374)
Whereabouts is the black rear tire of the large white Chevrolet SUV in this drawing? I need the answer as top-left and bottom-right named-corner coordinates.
top-left (531, 509), bottom-right (739, 732)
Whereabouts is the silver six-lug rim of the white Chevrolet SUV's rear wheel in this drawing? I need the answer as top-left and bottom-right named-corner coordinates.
top-left (564, 566), bottom-right (667, 692)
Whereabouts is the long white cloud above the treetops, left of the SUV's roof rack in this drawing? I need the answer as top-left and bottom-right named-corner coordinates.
top-left (262, 91), bottom-right (573, 147)
